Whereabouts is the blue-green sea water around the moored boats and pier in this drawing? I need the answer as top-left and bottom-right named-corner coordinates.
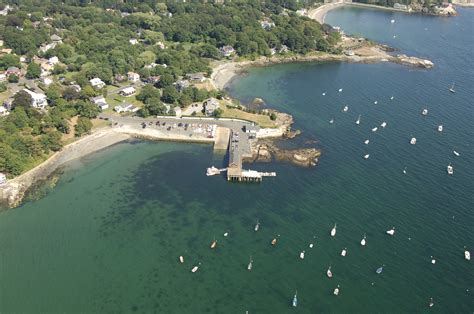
top-left (0, 8), bottom-right (474, 313)
